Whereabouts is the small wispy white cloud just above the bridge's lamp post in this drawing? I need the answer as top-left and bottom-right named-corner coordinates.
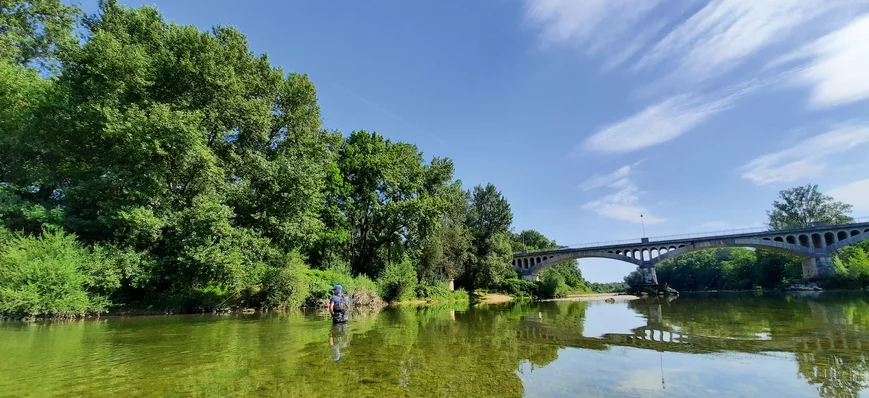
top-left (581, 162), bottom-right (666, 224)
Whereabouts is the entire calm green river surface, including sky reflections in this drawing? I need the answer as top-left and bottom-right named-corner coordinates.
top-left (0, 293), bottom-right (869, 397)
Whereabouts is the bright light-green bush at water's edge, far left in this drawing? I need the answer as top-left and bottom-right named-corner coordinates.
top-left (0, 229), bottom-right (116, 317)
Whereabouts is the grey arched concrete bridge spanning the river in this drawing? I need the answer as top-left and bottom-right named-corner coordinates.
top-left (513, 219), bottom-right (869, 285)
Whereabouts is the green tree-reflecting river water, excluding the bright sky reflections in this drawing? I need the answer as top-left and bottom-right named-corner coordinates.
top-left (0, 294), bottom-right (869, 398)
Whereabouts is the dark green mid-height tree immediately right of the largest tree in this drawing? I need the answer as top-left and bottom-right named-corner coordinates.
top-left (339, 131), bottom-right (453, 276)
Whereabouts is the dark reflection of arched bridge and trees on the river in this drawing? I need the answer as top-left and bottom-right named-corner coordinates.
top-left (508, 295), bottom-right (869, 396)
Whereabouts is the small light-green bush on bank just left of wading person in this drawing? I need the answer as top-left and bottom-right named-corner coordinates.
top-left (262, 252), bottom-right (310, 309)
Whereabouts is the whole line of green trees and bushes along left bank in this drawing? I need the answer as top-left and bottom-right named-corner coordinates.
top-left (0, 0), bottom-right (583, 315)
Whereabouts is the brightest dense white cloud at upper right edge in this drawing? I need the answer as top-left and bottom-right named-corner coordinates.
top-left (773, 15), bottom-right (869, 107)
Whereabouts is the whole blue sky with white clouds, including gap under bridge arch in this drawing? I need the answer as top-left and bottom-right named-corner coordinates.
top-left (83, 0), bottom-right (869, 282)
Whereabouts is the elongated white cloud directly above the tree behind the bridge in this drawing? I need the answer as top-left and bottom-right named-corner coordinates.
top-left (742, 125), bottom-right (869, 185)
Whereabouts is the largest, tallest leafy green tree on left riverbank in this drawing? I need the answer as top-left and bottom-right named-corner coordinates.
top-left (0, 1), bottom-right (330, 296)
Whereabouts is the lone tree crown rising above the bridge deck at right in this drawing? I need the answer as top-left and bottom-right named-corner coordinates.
top-left (767, 184), bottom-right (853, 230)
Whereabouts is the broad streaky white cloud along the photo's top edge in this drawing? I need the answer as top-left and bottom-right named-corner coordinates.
top-left (525, 0), bottom-right (869, 81)
